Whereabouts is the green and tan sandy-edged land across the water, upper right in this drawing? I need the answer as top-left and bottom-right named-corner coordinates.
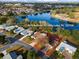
top-left (51, 7), bottom-right (79, 23)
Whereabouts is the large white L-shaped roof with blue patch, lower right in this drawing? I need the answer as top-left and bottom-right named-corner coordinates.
top-left (56, 42), bottom-right (77, 54)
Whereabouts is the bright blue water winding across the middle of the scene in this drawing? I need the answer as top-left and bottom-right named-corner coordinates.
top-left (16, 13), bottom-right (79, 30)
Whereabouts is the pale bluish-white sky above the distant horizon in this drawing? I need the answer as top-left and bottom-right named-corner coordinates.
top-left (0, 0), bottom-right (79, 3)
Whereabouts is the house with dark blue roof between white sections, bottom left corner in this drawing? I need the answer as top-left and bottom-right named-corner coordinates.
top-left (2, 52), bottom-right (23, 59)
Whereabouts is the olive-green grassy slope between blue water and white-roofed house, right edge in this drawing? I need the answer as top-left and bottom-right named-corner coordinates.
top-left (56, 29), bottom-right (79, 45)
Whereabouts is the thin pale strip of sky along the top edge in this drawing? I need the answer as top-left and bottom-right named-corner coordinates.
top-left (0, 0), bottom-right (79, 2)
